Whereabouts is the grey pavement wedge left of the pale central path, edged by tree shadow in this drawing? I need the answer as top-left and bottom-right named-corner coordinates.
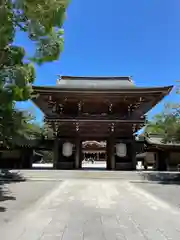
top-left (0, 181), bottom-right (59, 225)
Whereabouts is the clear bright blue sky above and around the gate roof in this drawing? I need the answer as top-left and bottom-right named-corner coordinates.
top-left (15, 0), bottom-right (180, 121)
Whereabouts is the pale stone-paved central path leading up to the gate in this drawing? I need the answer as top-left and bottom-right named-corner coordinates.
top-left (0, 179), bottom-right (180, 240)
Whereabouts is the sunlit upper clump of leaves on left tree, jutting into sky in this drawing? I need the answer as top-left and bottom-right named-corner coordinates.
top-left (13, 0), bottom-right (69, 64)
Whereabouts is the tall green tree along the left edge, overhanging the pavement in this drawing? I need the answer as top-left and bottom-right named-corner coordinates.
top-left (0, 0), bottom-right (68, 144)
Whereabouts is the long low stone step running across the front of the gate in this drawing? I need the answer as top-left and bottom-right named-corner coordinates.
top-left (8, 170), bottom-right (180, 181)
